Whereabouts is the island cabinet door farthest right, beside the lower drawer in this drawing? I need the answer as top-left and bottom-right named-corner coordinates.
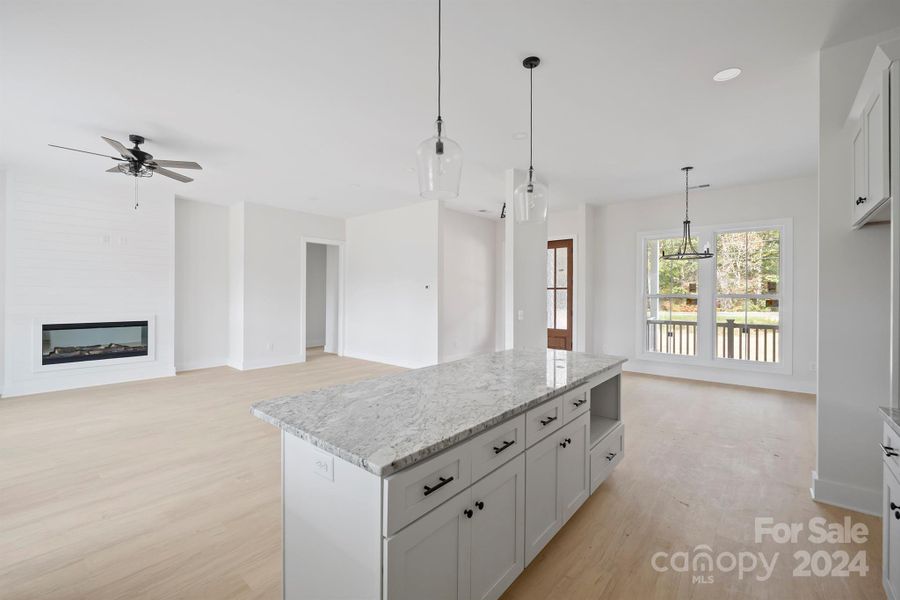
top-left (559, 414), bottom-right (591, 523)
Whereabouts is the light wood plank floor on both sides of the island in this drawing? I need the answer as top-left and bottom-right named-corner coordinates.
top-left (0, 353), bottom-right (884, 600)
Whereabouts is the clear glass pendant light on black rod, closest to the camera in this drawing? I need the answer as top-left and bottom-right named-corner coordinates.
top-left (416, 0), bottom-right (462, 200)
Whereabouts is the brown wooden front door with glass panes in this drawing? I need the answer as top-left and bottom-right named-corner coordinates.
top-left (547, 239), bottom-right (574, 350)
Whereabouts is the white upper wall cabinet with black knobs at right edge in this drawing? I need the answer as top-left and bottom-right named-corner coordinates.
top-left (848, 43), bottom-right (900, 227)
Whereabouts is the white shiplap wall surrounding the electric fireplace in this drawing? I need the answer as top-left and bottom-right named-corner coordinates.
top-left (4, 173), bottom-right (175, 396)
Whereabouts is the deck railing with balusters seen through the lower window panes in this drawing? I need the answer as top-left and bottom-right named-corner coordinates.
top-left (647, 319), bottom-right (781, 362)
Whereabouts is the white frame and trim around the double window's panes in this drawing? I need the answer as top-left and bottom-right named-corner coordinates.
top-left (635, 218), bottom-right (794, 374)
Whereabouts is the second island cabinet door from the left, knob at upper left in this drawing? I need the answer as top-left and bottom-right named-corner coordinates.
top-left (469, 454), bottom-right (525, 600)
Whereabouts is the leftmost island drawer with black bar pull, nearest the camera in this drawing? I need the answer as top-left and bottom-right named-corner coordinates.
top-left (383, 442), bottom-right (472, 535)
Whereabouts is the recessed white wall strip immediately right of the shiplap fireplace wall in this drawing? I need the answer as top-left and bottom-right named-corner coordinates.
top-left (175, 198), bottom-right (229, 371)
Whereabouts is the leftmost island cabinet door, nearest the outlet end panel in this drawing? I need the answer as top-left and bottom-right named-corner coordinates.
top-left (384, 490), bottom-right (471, 600)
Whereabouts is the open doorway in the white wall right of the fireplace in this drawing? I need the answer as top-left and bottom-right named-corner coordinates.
top-left (302, 240), bottom-right (343, 360)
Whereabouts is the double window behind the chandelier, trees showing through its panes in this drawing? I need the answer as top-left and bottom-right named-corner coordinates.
top-left (638, 220), bottom-right (791, 371)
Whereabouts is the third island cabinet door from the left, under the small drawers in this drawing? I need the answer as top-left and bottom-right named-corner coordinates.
top-left (525, 433), bottom-right (562, 565)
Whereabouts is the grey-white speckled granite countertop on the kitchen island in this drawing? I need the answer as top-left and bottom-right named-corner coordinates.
top-left (251, 350), bottom-right (625, 477)
